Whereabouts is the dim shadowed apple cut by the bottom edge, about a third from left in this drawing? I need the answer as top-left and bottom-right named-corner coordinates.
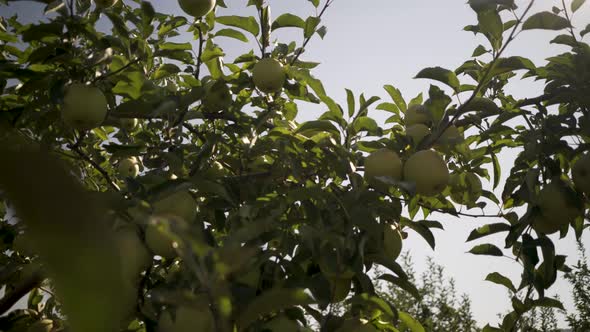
top-left (157, 305), bottom-right (215, 332)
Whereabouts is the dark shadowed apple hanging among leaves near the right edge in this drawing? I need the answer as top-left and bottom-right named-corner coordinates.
top-left (533, 182), bottom-right (582, 234)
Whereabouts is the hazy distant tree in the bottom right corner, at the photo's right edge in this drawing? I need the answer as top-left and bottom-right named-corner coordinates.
top-left (565, 242), bottom-right (590, 332)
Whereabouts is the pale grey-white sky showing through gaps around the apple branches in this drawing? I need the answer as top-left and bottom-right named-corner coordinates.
top-left (2, 0), bottom-right (590, 327)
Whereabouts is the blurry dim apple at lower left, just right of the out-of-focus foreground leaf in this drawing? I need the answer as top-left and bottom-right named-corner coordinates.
top-left (115, 227), bottom-right (152, 281)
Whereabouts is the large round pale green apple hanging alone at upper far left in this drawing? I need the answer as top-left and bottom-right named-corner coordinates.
top-left (61, 83), bottom-right (107, 130)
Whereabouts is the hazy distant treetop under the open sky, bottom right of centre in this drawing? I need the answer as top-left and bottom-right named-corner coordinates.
top-left (377, 252), bottom-right (480, 332)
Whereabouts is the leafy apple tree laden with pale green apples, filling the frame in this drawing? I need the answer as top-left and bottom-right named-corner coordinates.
top-left (0, 0), bottom-right (590, 332)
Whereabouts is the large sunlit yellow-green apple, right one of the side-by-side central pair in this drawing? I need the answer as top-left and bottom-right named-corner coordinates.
top-left (404, 150), bottom-right (449, 196)
